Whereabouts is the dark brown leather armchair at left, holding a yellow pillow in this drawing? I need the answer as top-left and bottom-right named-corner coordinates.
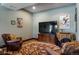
top-left (2, 34), bottom-right (22, 51)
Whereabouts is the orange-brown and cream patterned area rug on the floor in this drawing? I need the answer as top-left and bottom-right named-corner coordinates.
top-left (2, 40), bottom-right (60, 55)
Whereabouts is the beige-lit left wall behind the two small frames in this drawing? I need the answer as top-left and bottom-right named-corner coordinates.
top-left (0, 6), bottom-right (32, 45)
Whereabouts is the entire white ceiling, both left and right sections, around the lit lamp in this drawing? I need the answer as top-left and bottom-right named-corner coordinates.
top-left (1, 3), bottom-right (73, 13)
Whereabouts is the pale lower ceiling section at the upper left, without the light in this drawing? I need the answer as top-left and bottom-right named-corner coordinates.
top-left (1, 3), bottom-right (34, 10)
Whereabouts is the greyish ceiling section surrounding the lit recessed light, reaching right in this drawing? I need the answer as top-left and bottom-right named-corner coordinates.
top-left (25, 3), bottom-right (72, 12)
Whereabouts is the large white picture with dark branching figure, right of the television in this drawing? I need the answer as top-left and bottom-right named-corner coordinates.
top-left (59, 14), bottom-right (70, 29)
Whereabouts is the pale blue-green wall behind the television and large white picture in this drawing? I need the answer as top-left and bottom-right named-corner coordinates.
top-left (33, 4), bottom-right (76, 37)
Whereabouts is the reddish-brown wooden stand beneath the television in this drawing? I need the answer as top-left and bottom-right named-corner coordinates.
top-left (38, 33), bottom-right (56, 44)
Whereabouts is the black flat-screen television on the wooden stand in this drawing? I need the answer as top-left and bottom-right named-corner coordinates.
top-left (39, 21), bottom-right (58, 34)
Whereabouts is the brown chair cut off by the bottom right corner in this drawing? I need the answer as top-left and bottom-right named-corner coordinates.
top-left (61, 41), bottom-right (79, 55)
